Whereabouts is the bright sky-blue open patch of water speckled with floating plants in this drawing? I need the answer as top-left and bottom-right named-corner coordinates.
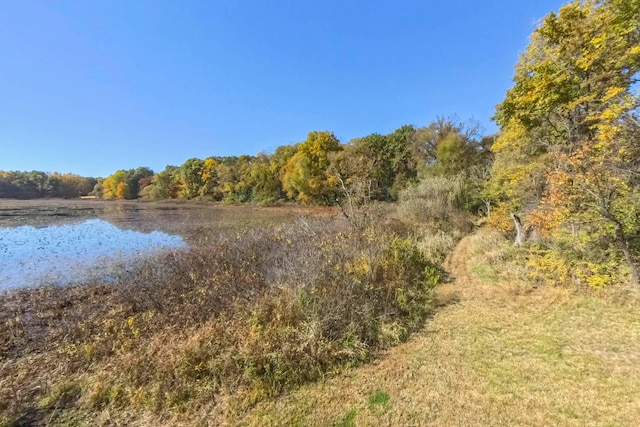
top-left (0, 219), bottom-right (187, 290)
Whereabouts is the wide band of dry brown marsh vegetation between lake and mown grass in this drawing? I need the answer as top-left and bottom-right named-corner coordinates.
top-left (0, 210), bottom-right (441, 425)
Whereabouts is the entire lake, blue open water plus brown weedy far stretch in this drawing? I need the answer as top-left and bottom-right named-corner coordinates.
top-left (0, 199), bottom-right (328, 291)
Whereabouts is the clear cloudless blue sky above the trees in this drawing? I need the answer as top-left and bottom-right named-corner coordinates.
top-left (0, 0), bottom-right (564, 176)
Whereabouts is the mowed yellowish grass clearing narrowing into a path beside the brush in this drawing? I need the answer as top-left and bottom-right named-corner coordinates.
top-left (232, 232), bottom-right (640, 426)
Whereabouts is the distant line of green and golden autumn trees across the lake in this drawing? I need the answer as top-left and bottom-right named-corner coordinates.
top-left (0, 119), bottom-right (492, 205)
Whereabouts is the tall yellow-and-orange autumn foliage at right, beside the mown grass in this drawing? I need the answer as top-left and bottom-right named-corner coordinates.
top-left (488, 0), bottom-right (640, 282)
